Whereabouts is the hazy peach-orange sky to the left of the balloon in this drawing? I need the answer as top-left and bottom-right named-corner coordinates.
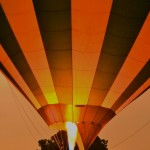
top-left (0, 72), bottom-right (57, 150)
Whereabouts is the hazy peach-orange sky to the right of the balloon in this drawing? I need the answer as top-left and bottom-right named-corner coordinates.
top-left (99, 89), bottom-right (150, 150)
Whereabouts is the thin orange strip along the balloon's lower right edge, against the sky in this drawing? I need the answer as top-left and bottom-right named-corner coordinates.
top-left (116, 78), bottom-right (150, 113)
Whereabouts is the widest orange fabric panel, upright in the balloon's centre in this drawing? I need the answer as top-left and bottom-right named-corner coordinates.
top-left (72, 0), bottom-right (112, 105)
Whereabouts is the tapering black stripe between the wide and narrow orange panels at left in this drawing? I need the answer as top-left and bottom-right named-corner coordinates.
top-left (0, 5), bottom-right (46, 104)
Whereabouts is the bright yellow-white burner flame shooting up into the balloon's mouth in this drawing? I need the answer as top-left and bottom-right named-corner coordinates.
top-left (66, 122), bottom-right (77, 150)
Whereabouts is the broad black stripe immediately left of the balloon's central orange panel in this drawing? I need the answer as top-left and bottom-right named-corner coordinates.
top-left (33, 0), bottom-right (73, 120)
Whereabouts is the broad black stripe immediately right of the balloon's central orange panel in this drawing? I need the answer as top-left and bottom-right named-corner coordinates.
top-left (87, 0), bottom-right (150, 103)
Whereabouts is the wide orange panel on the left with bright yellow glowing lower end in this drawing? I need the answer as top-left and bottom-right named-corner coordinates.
top-left (2, 0), bottom-right (58, 104)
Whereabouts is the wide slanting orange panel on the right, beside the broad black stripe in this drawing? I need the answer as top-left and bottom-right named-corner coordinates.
top-left (102, 14), bottom-right (150, 108)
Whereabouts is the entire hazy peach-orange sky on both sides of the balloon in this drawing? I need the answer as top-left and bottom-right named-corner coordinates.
top-left (0, 72), bottom-right (150, 150)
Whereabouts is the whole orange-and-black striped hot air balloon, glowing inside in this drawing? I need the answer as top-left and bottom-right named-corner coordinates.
top-left (0, 0), bottom-right (150, 150)
